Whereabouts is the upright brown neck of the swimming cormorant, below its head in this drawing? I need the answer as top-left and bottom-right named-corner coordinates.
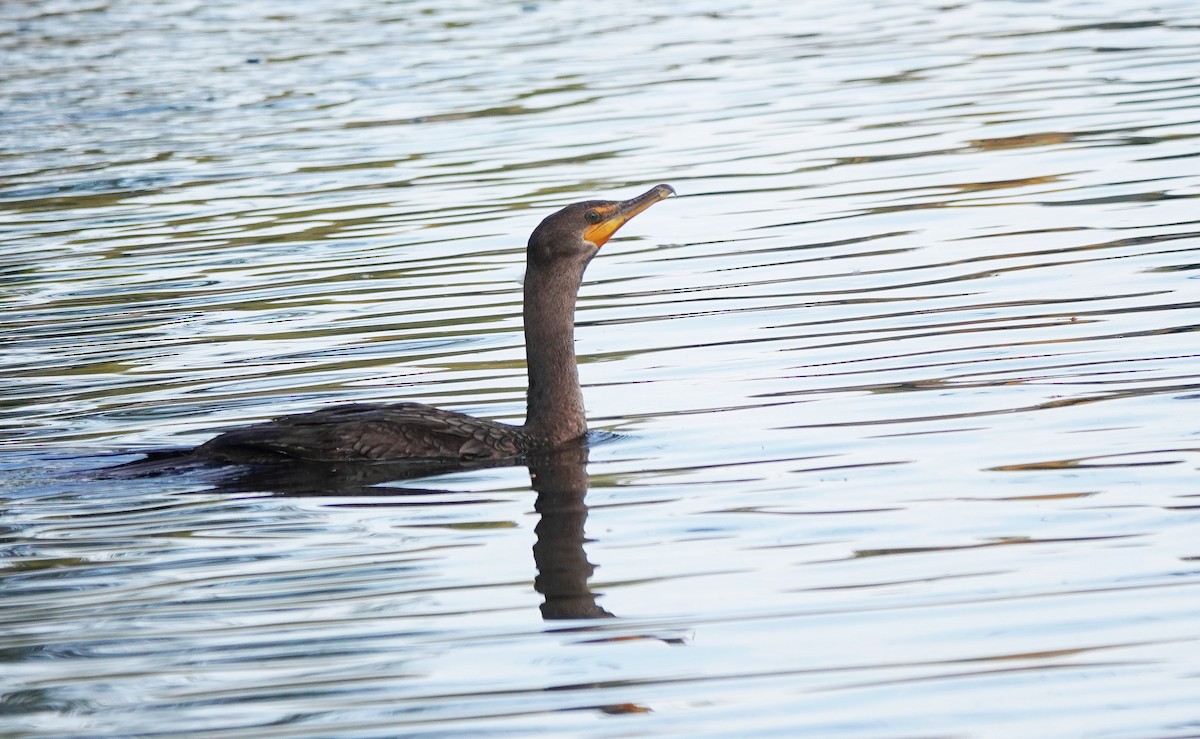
top-left (524, 262), bottom-right (588, 446)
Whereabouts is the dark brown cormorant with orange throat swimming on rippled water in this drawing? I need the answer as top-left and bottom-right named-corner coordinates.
top-left (114, 185), bottom-right (674, 476)
